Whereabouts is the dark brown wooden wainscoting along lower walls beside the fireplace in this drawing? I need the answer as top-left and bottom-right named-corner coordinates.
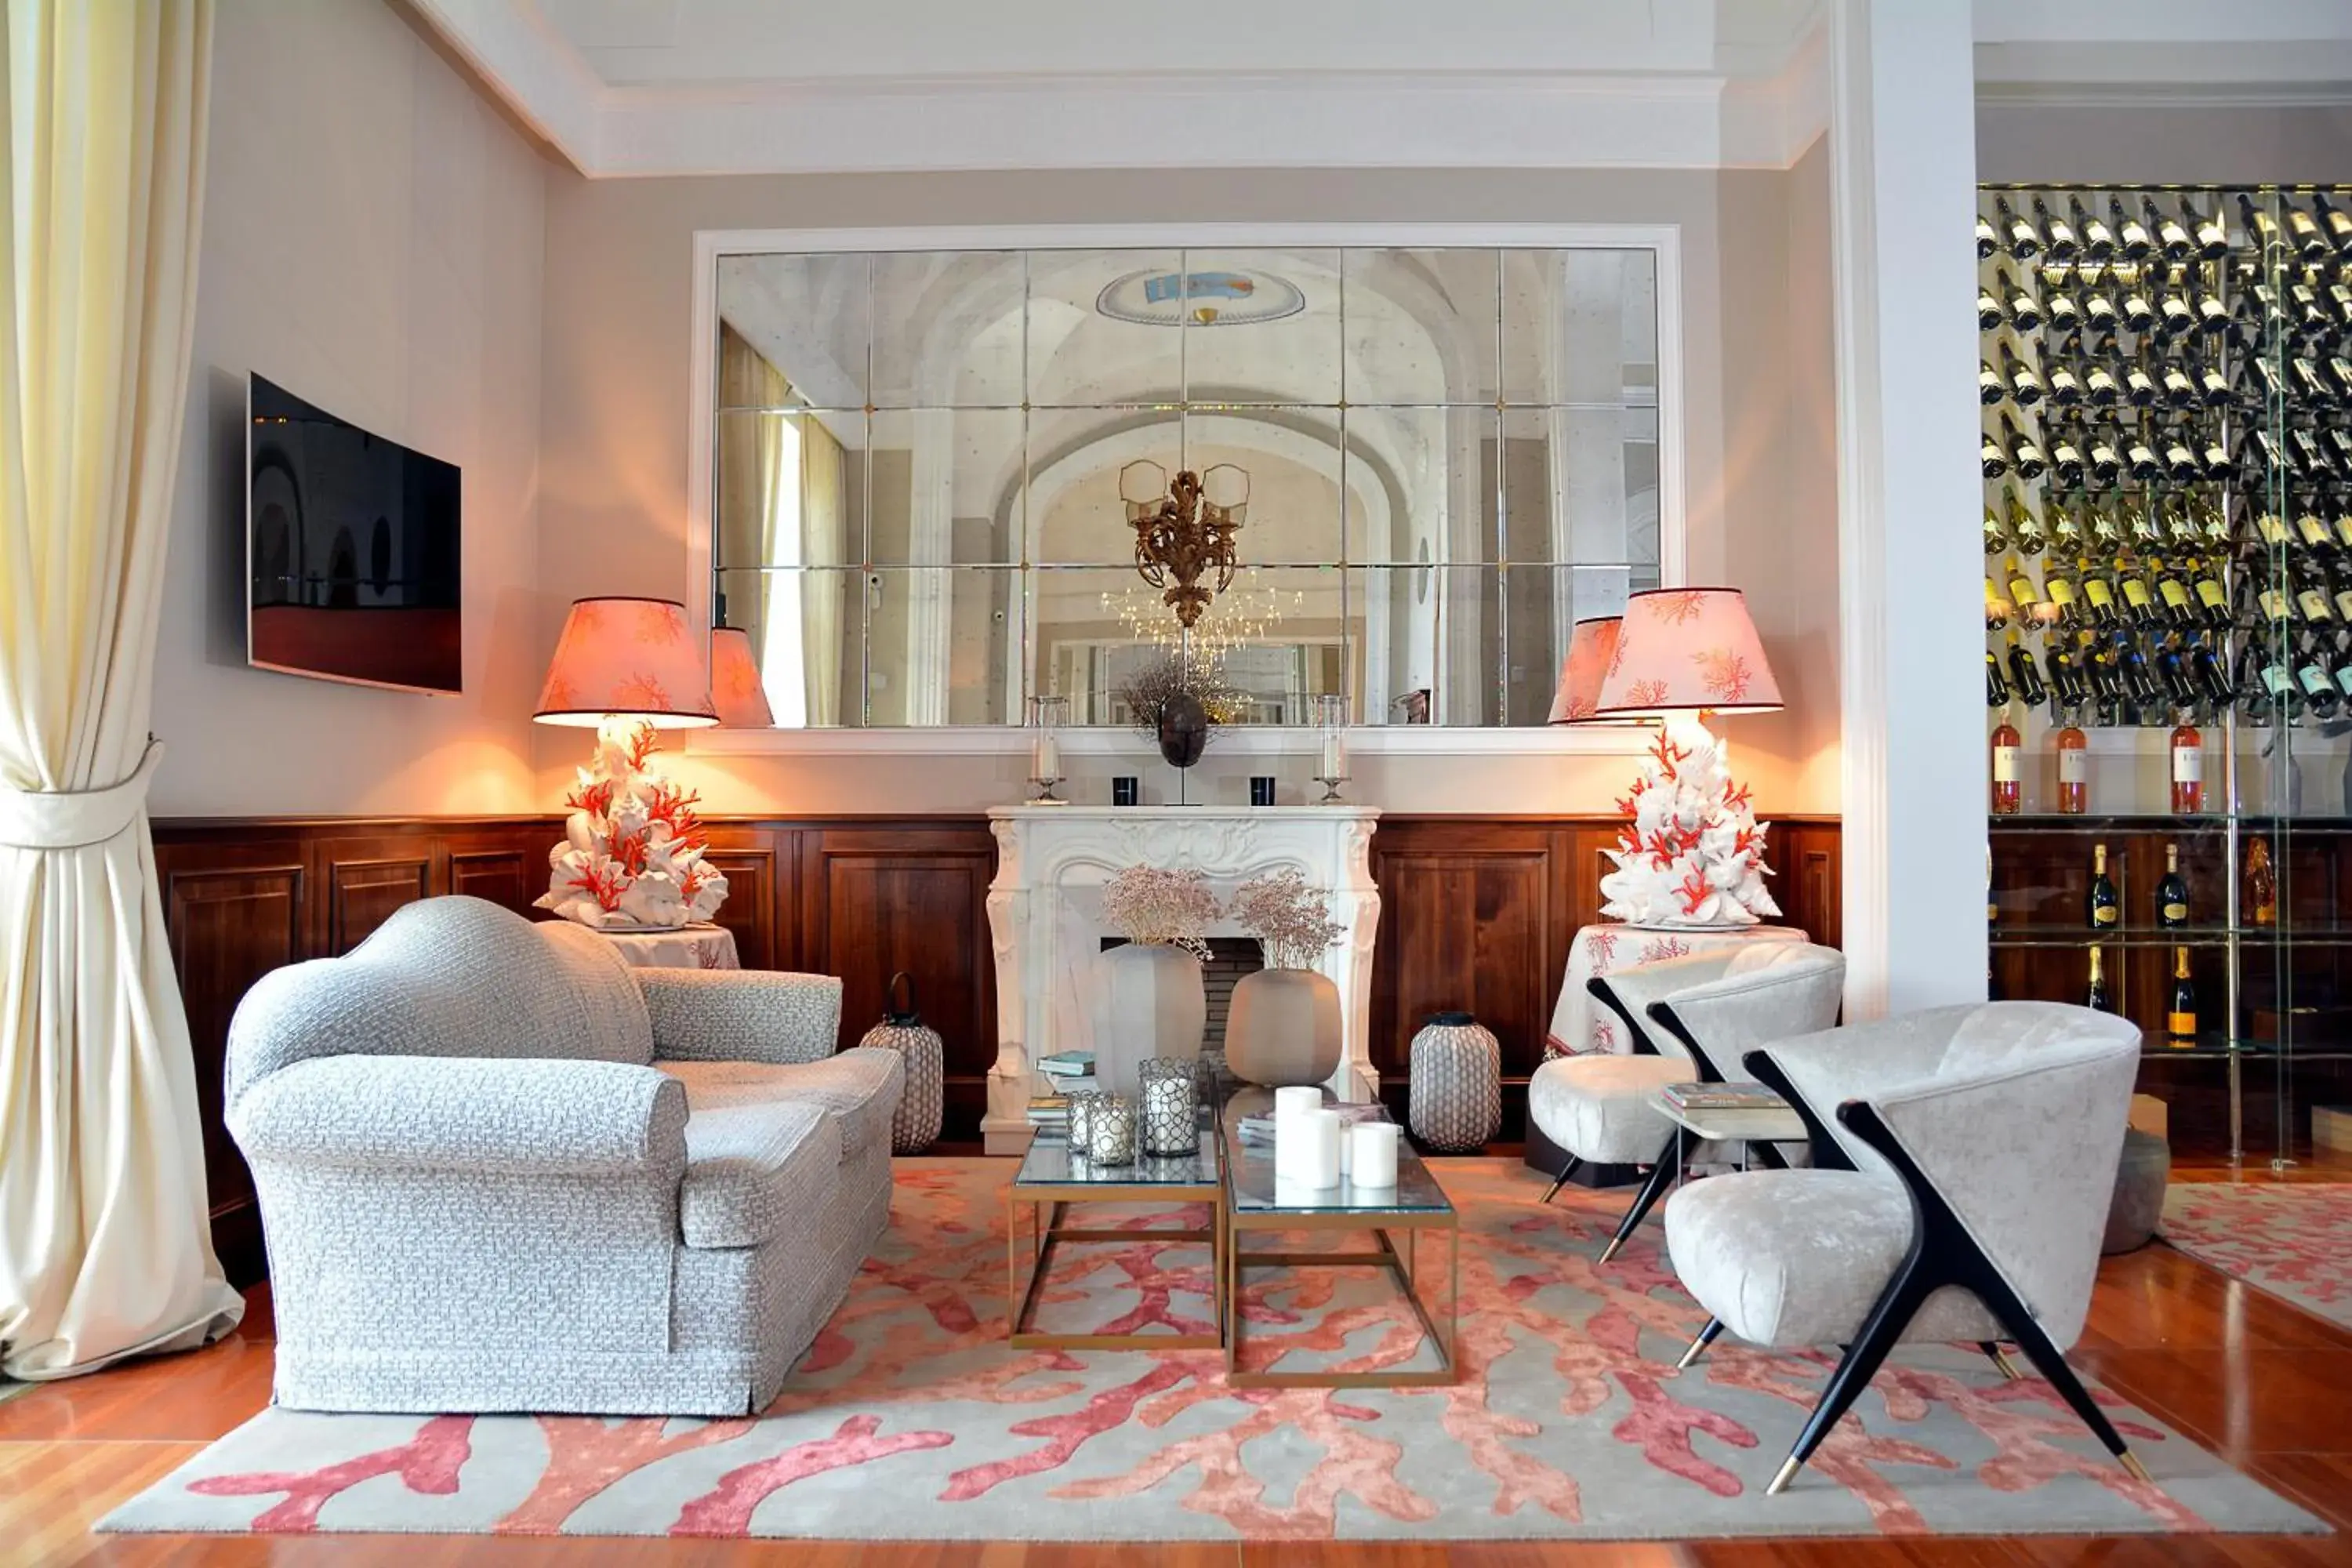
top-left (155, 815), bottom-right (1835, 1283)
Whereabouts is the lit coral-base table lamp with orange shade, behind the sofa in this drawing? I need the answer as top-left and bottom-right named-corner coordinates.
top-left (532, 597), bottom-right (727, 931)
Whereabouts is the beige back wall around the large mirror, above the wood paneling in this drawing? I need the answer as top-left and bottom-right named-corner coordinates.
top-left (536, 164), bottom-right (1837, 811)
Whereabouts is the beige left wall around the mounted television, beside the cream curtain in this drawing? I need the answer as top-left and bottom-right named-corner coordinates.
top-left (151, 0), bottom-right (546, 815)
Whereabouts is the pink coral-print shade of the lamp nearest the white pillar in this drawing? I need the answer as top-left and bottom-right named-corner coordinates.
top-left (1595, 588), bottom-right (1780, 720)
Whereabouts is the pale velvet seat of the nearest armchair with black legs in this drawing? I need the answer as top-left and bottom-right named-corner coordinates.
top-left (1665, 1171), bottom-right (2002, 1347)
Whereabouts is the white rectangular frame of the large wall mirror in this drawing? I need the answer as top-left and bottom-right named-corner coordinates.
top-left (682, 223), bottom-right (1684, 757)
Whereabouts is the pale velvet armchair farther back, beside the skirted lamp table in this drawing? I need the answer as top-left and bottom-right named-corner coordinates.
top-left (1526, 942), bottom-right (1846, 1262)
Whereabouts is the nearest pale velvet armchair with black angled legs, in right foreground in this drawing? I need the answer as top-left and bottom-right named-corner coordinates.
top-left (1665, 1001), bottom-right (2147, 1493)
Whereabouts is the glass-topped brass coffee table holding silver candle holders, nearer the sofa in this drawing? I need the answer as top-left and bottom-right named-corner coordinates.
top-left (1004, 1123), bottom-right (1230, 1349)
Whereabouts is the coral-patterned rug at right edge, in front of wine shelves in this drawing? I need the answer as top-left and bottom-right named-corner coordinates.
top-left (2159, 1182), bottom-right (2352, 1328)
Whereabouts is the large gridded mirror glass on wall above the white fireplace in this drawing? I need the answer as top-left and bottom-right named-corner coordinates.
top-left (710, 247), bottom-right (1670, 727)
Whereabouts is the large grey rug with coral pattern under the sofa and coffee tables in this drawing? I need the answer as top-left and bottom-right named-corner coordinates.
top-left (101, 1159), bottom-right (2319, 1540)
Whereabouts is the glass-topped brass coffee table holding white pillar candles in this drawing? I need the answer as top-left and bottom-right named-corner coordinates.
top-left (1221, 1123), bottom-right (1461, 1389)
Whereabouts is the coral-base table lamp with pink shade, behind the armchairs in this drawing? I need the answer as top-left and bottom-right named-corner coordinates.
top-left (1569, 588), bottom-right (1780, 931)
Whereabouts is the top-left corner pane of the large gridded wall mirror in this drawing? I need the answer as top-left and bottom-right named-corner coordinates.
top-left (717, 254), bottom-right (873, 409)
